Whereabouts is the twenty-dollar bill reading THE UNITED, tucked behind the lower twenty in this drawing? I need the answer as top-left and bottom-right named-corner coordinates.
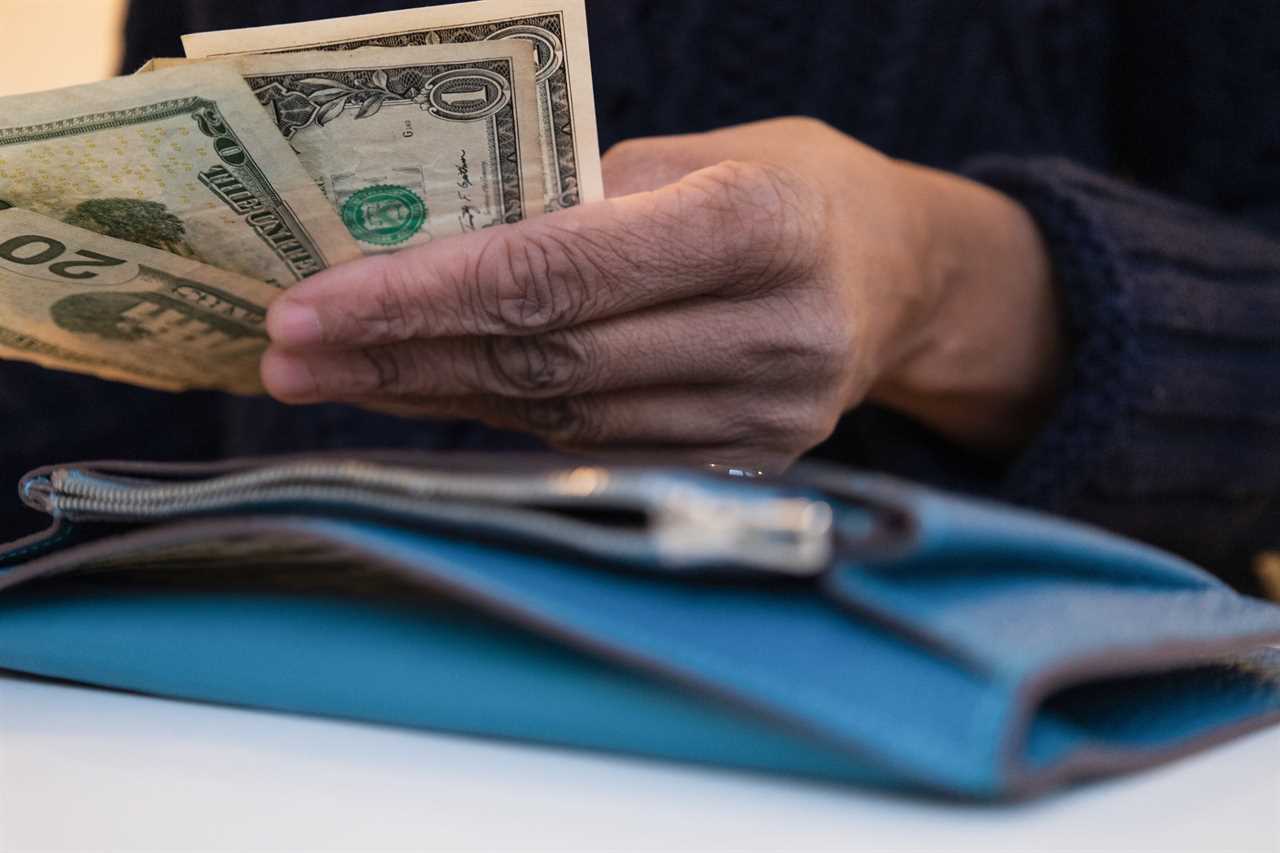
top-left (0, 64), bottom-right (361, 288)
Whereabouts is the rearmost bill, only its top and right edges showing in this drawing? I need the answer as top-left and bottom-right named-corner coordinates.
top-left (183, 0), bottom-right (604, 210)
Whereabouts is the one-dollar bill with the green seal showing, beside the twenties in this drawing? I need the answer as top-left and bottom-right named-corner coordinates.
top-left (232, 40), bottom-right (544, 252)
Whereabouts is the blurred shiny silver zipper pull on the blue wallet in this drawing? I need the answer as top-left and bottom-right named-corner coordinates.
top-left (652, 484), bottom-right (835, 578)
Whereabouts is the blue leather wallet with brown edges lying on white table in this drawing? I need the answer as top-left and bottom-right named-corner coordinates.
top-left (0, 455), bottom-right (1280, 798)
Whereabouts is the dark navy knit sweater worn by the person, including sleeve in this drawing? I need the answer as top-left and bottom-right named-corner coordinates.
top-left (0, 0), bottom-right (1280, 587)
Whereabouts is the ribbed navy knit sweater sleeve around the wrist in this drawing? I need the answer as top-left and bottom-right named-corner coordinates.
top-left (966, 158), bottom-right (1280, 587)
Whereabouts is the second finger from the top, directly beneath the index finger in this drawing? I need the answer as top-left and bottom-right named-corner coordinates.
top-left (262, 301), bottom-right (788, 403)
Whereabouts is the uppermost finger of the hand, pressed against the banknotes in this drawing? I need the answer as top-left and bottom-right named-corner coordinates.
top-left (268, 157), bottom-right (817, 348)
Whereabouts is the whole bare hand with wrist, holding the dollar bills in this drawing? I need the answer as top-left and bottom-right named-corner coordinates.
top-left (262, 119), bottom-right (1060, 469)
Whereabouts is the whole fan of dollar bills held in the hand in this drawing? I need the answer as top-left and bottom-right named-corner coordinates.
top-left (0, 0), bottom-right (603, 394)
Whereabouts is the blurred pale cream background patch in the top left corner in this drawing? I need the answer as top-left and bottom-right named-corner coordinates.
top-left (0, 0), bottom-right (125, 95)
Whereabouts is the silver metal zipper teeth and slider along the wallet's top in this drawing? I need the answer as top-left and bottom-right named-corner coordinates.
top-left (47, 462), bottom-right (829, 574)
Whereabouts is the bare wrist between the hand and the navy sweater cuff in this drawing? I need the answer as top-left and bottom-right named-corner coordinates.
top-left (869, 163), bottom-right (1065, 452)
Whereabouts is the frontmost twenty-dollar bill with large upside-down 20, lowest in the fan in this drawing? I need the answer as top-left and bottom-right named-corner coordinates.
top-left (0, 205), bottom-right (279, 394)
